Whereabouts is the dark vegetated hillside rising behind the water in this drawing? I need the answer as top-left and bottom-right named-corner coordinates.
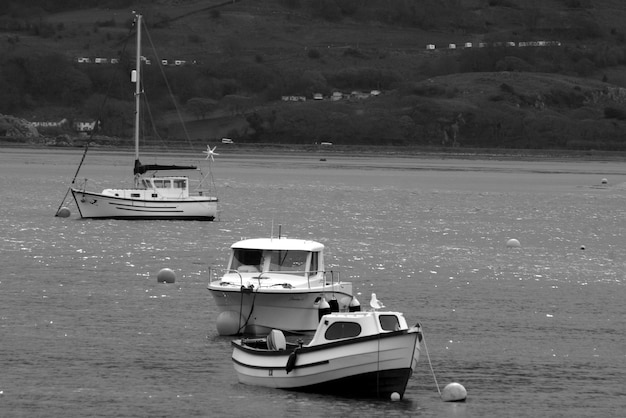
top-left (0, 0), bottom-right (626, 150)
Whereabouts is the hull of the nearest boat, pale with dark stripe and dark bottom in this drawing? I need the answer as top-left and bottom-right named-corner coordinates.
top-left (232, 328), bottom-right (421, 398)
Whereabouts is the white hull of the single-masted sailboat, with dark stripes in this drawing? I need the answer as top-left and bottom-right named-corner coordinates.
top-left (72, 189), bottom-right (218, 221)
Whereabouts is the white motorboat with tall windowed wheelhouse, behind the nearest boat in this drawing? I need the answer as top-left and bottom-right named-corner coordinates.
top-left (208, 237), bottom-right (360, 335)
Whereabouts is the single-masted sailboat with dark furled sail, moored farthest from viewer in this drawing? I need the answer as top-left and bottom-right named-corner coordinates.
top-left (71, 14), bottom-right (218, 221)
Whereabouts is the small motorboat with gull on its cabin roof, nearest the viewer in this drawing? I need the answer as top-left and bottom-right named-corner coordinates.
top-left (232, 311), bottom-right (422, 400)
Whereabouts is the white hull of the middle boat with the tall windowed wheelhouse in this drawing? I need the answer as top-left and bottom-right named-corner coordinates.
top-left (208, 283), bottom-right (352, 335)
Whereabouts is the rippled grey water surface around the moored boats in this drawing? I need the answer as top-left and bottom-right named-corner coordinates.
top-left (0, 147), bottom-right (626, 417)
